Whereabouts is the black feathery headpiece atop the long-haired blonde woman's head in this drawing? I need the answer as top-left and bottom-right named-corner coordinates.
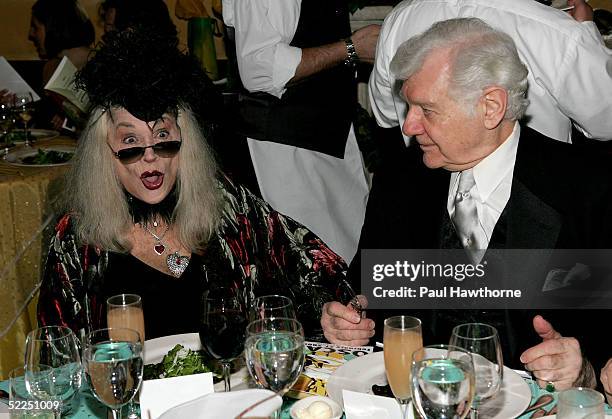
top-left (76, 26), bottom-right (222, 124)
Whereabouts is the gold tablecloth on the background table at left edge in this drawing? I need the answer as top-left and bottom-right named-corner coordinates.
top-left (0, 138), bottom-right (74, 380)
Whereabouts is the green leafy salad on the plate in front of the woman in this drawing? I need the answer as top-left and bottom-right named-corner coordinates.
top-left (144, 345), bottom-right (215, 380)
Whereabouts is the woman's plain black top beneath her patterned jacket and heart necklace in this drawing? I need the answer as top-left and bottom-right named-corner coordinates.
top-left (103, 253), bottom-right (206, 339)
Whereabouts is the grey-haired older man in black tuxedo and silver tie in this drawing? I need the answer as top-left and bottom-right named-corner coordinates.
top-left (321, 18), bottom-right (612, 389)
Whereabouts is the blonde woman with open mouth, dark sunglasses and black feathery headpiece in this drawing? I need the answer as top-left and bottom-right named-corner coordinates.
top-left (38, 29), bottom-right (360, 339)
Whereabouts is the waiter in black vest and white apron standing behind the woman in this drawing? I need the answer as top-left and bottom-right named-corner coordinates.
top-left (223, 0), bottom-right (380, 261)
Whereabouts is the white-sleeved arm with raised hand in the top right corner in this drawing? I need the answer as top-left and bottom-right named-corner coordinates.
top-left (551, 0), bottom-right (612, 140)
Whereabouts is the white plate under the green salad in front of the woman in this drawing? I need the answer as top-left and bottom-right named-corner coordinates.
top-left (144, 333), bottom-right (249, 391)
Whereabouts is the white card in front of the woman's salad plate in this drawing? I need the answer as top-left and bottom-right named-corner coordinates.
top-left (140, 372), bottom-right (214, 419)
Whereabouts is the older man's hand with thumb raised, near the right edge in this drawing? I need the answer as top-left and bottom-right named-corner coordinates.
top-left (521, 315), bottom-right (583, 390)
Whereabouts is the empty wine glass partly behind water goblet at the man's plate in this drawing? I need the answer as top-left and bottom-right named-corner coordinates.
top-left (449, 323), bottom-right (504, 419)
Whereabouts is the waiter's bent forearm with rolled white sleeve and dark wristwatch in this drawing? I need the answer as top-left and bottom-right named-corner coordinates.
top-left (223, 0), bottom-right (379, 97)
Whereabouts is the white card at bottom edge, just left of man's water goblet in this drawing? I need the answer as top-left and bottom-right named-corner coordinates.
top-left (342, 390), bottom-right (412, 419)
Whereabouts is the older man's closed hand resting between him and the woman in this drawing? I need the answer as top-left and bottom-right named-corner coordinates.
top-left (321, 295), bottom-right (374, 346)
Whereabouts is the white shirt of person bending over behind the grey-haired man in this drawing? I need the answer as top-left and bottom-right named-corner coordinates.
top-left (369, 0), bottom-right (612, 142)
